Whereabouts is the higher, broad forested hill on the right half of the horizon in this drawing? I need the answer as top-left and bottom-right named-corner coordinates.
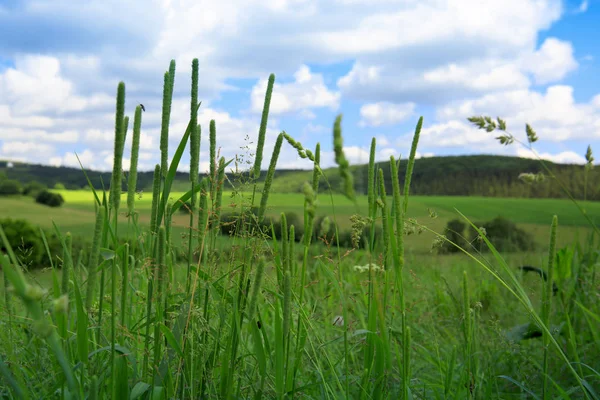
top-left (272, 155), bottom-right (600, 200)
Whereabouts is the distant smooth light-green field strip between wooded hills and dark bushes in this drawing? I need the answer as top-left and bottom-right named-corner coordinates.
top-left (0, 191), bottom-right (600, 255)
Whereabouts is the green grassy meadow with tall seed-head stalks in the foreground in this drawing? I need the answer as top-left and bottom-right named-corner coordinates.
top-left (0, 60), bottom-right (600, 399)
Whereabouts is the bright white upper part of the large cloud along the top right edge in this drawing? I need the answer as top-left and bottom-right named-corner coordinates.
top-left (310, 0), bottom-right (561, 56)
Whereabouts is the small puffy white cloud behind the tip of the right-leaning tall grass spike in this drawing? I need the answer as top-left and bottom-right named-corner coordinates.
top-left (251, 65), bottom-right (340, 117)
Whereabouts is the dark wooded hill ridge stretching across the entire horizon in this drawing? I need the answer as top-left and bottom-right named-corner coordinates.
top-left (0, 155), bottom-right (600, 200)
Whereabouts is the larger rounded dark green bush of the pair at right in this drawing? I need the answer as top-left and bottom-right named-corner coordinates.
top-left (469, 217), bottom-right (535, 252)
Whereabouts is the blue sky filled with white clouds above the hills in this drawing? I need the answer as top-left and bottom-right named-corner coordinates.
top-left (0, 0), bottom-right (600, 171)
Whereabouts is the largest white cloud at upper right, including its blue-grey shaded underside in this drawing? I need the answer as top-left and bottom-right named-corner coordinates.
top-left (336, 0), bottom-right (577, 104)
